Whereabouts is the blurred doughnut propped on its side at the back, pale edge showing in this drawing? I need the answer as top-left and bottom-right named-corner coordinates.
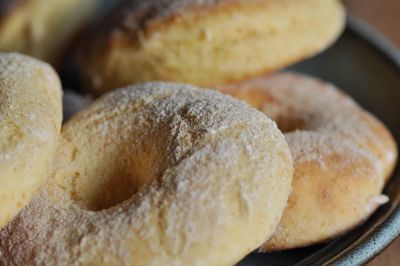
top-left (77, 0), bottom-right (345, 94)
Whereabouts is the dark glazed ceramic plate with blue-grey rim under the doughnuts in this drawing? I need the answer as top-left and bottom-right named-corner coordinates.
top-left (239, 18), bottom-right (400, 266)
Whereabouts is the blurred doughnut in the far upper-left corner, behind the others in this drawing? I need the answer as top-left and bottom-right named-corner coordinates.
top-left (0, 0), bottom-right (99, 63)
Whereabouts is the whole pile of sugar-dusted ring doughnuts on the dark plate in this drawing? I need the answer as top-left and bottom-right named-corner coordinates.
top-left (0, 0), bottom-right (397, 265)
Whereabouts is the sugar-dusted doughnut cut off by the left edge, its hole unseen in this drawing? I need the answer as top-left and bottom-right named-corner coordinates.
top-left (0, 53), bottom-right (62, 228)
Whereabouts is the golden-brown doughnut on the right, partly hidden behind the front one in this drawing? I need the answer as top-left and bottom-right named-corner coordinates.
top-left (220, 73), bottom-right (397, 251)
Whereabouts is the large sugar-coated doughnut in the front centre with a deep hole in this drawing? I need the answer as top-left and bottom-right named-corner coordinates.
top-left (0, 83), bottom-right (293, 265)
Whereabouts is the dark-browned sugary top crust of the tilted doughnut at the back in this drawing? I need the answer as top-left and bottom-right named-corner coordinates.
top-left (83, 0), bottom-right (236, 56)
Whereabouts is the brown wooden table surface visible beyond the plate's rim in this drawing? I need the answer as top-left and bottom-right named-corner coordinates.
top-left (345, 0), bottom-right (400, 266)
